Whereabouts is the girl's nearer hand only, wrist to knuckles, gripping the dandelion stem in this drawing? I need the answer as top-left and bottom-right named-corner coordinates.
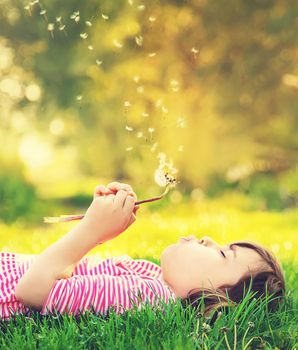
top-left (82, 189), bottom-right (136, 244)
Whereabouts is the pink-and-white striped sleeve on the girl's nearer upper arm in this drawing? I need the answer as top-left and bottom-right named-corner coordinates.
top-left (41, 275), bottom-right (175, 315)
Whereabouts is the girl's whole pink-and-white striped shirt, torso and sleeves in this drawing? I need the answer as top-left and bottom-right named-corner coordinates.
top-left (0, 252), bottom-right (176, 319)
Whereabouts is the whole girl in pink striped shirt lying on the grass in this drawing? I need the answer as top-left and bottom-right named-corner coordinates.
top-left (0, 182), bottom-right (285, 319)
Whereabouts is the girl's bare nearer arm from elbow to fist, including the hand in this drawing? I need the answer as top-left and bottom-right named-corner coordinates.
top-left (15, 190), bottom-right (136, 310)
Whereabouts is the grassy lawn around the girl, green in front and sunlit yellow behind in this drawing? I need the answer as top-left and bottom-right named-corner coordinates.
top-left (0, 198), bottom-right (298, 350)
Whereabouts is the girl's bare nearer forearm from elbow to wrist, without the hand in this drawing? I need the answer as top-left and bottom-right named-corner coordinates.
top-left (15, 220), bottom-right (98, 308)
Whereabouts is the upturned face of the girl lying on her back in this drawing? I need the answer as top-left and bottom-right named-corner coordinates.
top-left (160, 235), bottom-right (264, 298)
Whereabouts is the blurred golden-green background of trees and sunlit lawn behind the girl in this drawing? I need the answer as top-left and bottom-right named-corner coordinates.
top-left (0, 0), bottom-right (298, 260)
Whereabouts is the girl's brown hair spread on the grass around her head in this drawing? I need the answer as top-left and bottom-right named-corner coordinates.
top-left (181, 242), bottom-right (285, 315)
